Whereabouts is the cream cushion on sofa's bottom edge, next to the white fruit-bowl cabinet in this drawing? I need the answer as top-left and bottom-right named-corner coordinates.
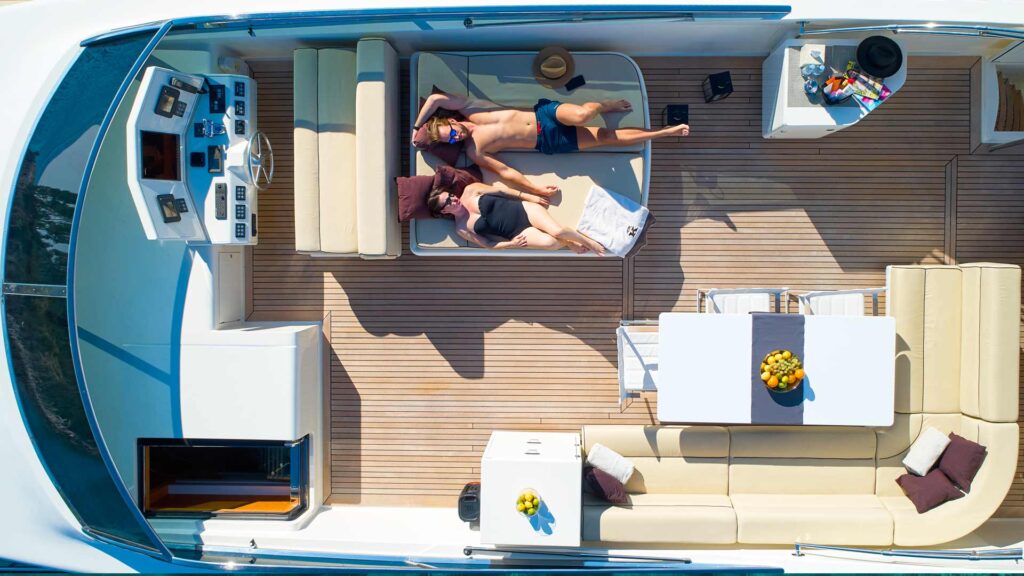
top-left (583, 494), bottom-right (736, 544)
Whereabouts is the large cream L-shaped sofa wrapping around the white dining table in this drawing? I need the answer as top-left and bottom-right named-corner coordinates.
top-left (583, 263), bottom-right (1021, 546)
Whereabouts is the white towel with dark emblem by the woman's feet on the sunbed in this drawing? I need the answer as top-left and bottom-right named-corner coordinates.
top-left (577, 184), bottom-right (649, 257)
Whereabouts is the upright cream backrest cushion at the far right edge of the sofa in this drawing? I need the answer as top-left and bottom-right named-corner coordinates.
top-left (961, 263), bottom-right (1021, 422)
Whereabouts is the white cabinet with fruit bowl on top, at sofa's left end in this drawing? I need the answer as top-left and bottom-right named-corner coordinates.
top-left (480, 430), bottom-right (583, 546)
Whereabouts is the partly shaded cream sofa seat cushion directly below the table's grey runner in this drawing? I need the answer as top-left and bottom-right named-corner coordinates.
top-left (729, 426), bottom-right (877, 495)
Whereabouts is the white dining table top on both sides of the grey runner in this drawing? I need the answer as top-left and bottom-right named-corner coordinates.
top-left (657, 313), bottom-right (896, 426)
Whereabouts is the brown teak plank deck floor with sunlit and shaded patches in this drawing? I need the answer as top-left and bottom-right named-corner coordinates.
top-left (250, 53), bottom-right (1024, 516)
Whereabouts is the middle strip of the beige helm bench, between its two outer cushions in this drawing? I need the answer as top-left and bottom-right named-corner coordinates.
top-left (317, 48), bottom-right (358, 253)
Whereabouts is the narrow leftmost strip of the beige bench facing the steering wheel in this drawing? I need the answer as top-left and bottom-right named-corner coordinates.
top-left (292, 48), bottom-right (321, 252)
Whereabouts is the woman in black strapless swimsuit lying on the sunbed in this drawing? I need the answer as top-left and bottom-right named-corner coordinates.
top-left (427, 179), bottom-right (604, 251)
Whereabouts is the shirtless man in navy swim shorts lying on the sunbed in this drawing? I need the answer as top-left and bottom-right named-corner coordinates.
top-left (413, 94), bottom-right (690, 197)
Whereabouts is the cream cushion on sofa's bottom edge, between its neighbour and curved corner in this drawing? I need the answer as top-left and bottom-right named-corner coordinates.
top-left (731, 488), bottom-right (893, 546)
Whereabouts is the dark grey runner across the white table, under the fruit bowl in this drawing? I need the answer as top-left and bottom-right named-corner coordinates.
top-left (751, 314), bottom-right (807, 424)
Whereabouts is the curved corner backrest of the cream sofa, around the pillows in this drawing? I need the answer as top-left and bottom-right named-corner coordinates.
top-left (879, 416), bottom-right (1020, 546)
